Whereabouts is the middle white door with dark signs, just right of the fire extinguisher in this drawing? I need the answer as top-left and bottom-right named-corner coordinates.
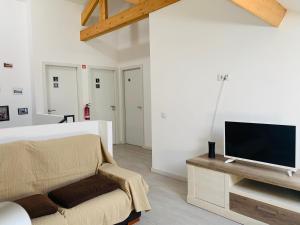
top-left (91, 69), bottom-right (117, 143)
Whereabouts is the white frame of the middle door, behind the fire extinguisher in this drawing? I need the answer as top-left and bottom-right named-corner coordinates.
top-left (88, 65), bottom-right (120, 144)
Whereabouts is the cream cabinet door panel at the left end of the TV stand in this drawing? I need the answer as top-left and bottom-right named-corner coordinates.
top-left (188, 166), bottom-right (225, 208)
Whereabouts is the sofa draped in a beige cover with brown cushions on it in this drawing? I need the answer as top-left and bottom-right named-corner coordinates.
top-left (0, 135), bottom-right (151, 225)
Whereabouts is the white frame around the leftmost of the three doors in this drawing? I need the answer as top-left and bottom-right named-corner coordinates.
top-left (42, 62), bottom-right (83, 121)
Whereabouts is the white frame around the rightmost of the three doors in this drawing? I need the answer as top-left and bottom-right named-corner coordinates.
top-left (120, 65), bottom-right (145, 147)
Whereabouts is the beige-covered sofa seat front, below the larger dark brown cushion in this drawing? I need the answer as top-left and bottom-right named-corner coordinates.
top-left (59, 189), bottom-right (133, 225)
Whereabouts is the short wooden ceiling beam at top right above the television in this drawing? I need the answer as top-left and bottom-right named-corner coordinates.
top-left (232, 0), bottom-right (287, 27)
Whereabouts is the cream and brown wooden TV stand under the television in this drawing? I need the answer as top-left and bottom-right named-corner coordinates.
top-left (187, 155), bottom-right (300, 225)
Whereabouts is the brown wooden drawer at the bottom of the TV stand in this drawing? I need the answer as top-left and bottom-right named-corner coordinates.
top-left (230, 193), bottom-right (300, 225)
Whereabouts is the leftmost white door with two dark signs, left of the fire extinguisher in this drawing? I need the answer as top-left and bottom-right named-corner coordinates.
top-left (46, 66), bottom-right (78, 121)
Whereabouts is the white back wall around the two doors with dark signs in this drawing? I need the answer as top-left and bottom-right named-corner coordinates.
top-left (31, 0), bottom-right (117, 121)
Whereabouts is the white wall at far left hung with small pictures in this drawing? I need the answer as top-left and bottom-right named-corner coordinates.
top-left (0, 0), bottom-right (32, 128)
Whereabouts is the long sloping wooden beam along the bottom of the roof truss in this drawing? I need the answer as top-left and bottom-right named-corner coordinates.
top-left (80, 0), bottom-right (180, 41)
